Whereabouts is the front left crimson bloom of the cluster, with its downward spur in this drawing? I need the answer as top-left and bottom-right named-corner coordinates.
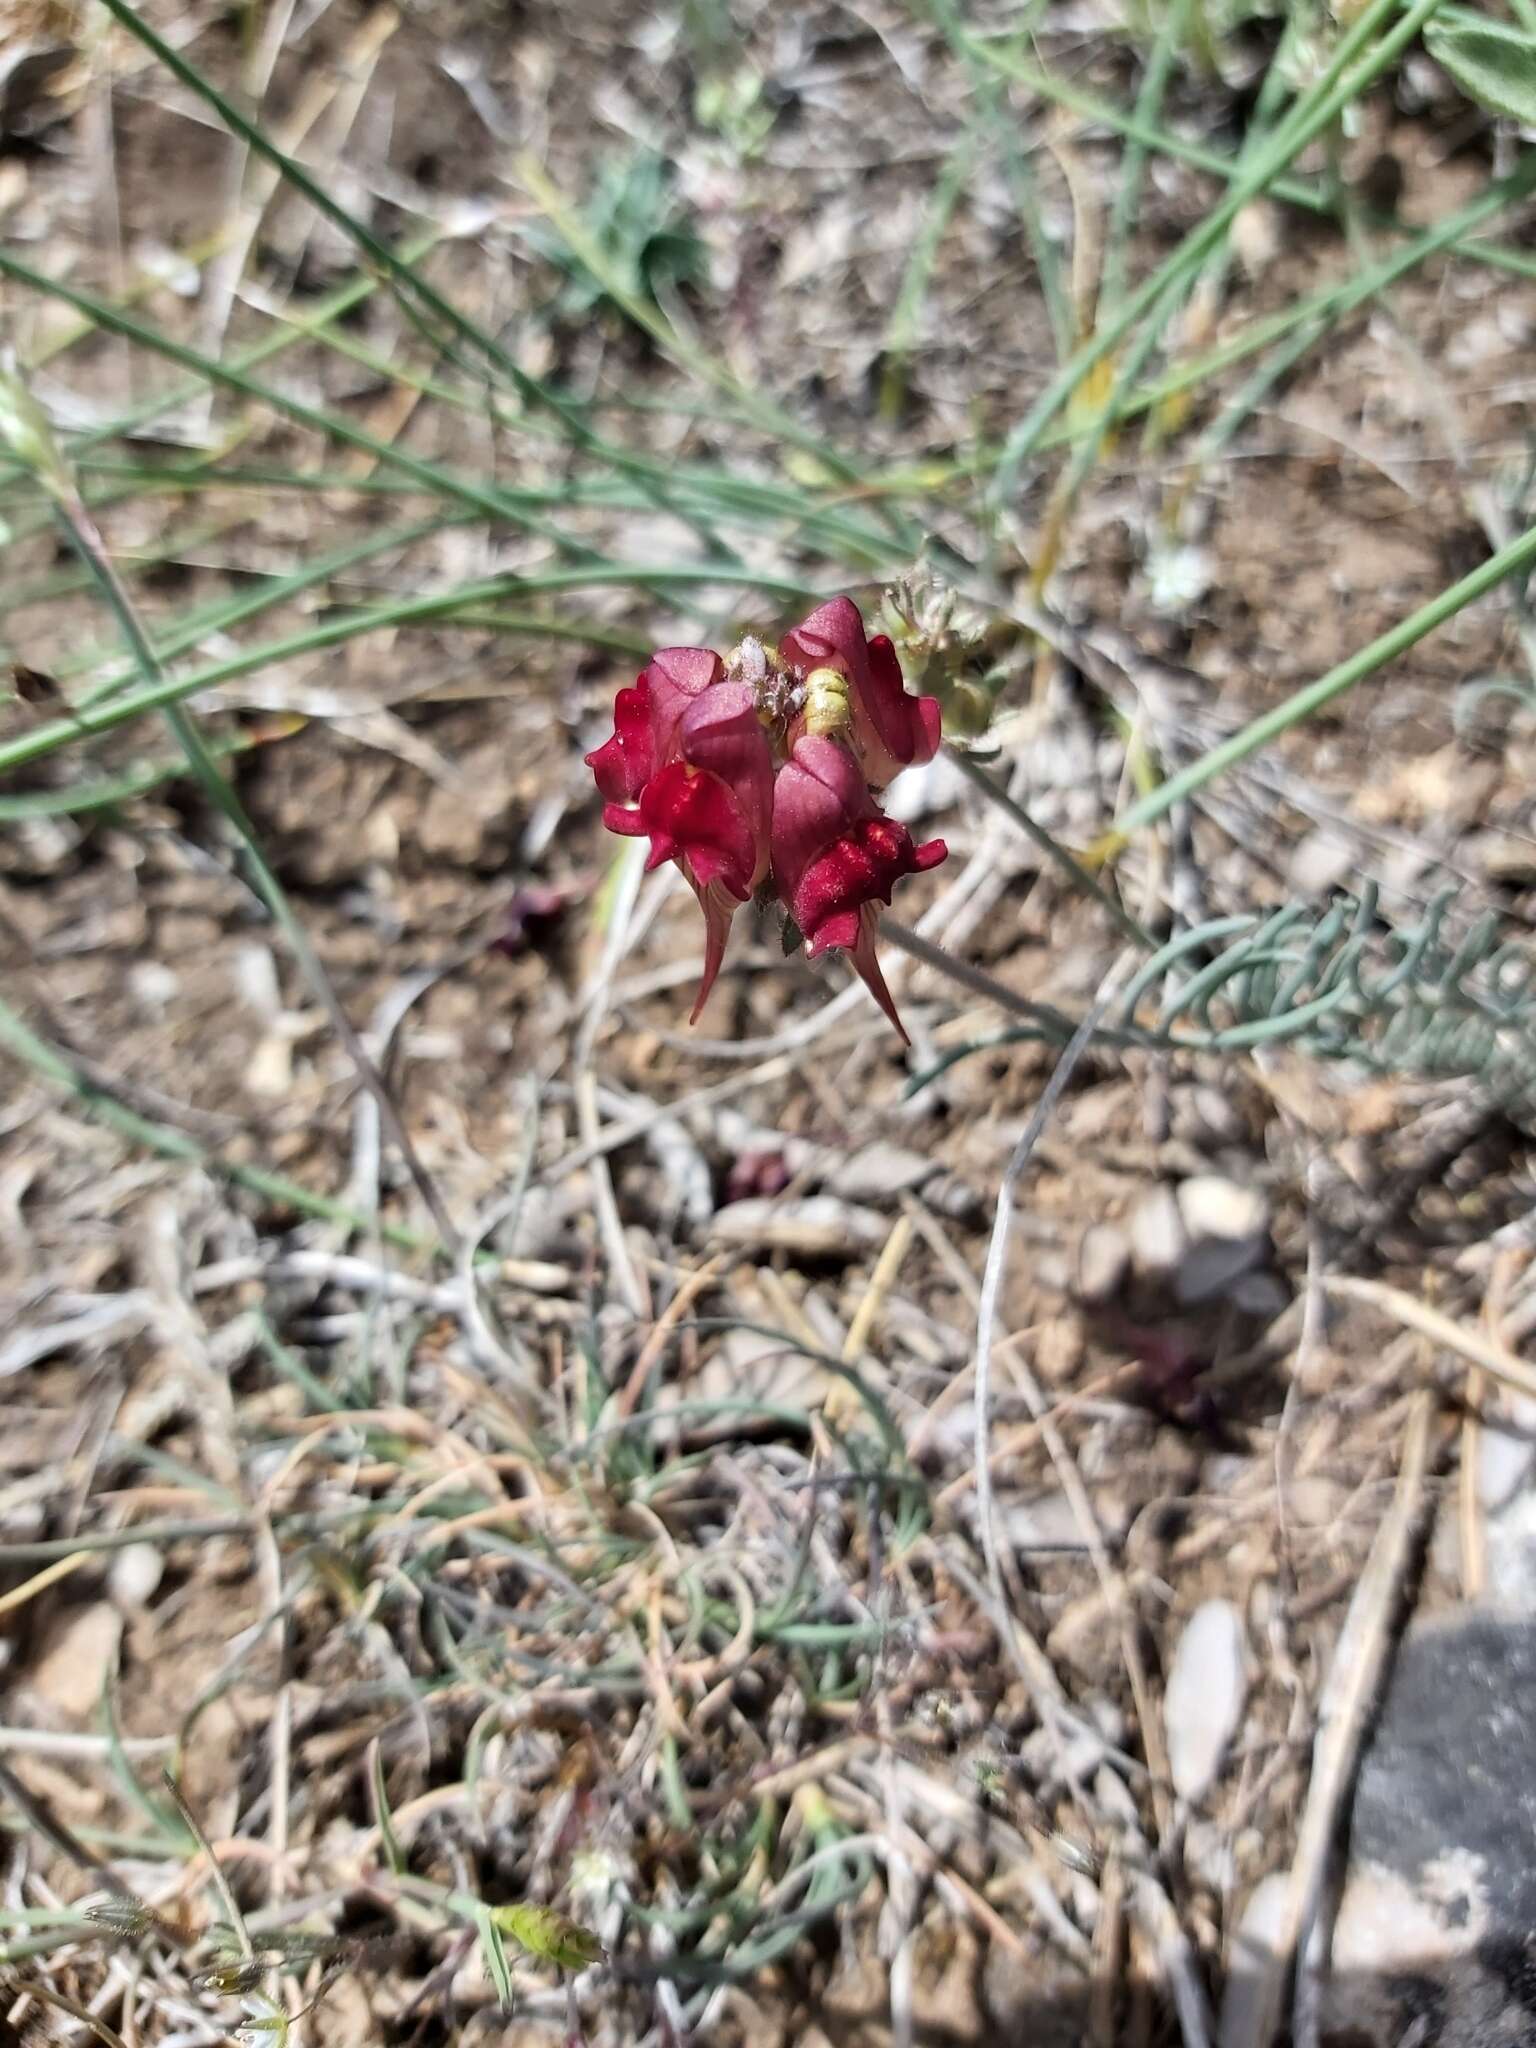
top-left (588, 667), bottom-right (774, 1022)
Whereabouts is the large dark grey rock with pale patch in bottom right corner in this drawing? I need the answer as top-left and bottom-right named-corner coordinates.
top-left (1323, 1614), bottom-right (1536, 2048)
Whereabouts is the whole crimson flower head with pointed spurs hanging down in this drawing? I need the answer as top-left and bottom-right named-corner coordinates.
top-left (586, 598), bottom-right (946, 1038)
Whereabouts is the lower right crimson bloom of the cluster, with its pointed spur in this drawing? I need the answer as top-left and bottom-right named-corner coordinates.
top-left (772, 737), bottom-right (948, 1038)
